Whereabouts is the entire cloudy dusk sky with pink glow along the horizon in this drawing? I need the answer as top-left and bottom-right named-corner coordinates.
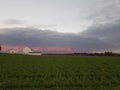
top-left (0, 0), bottom-right (120, 52)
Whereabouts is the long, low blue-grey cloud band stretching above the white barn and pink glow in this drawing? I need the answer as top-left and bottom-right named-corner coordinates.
top-left (0, 25), bottom-right (111, 52)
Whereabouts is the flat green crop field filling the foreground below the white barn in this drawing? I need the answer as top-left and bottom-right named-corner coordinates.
top-left (0, 54), bottom-right (120, 90)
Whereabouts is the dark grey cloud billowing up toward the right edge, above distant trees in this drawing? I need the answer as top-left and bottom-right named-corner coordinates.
top-left (81, 22), bottom-right (120, 50)
